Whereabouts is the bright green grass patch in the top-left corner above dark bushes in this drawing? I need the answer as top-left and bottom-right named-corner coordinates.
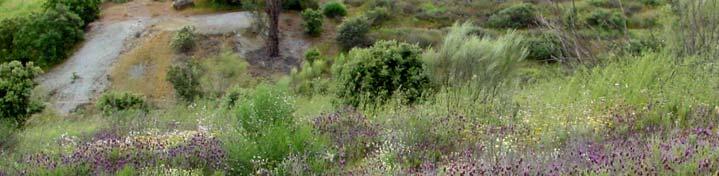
top-left (0, 0), bottom-right (45, 20)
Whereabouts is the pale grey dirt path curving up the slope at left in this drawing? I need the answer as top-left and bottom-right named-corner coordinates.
top-left (38, 6), bottom-right (252, 114)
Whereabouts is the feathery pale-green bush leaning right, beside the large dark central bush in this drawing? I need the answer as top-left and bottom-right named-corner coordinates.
top-left (425, 23), bottom-right (527, 99)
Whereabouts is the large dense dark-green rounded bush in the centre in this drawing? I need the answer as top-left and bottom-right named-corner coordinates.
top-left (338, 41), bottom-right (430, 106)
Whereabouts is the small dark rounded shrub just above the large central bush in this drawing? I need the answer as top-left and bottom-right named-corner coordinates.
top-left (335, 17), bottom-right (370, 50)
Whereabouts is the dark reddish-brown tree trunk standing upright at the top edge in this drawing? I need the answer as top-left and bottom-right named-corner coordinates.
top-left (265, 0), bottom-right (282, 58)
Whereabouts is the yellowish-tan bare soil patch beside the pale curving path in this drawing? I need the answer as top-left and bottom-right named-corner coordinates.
top-left (110, 32), bottom-right (174, 103)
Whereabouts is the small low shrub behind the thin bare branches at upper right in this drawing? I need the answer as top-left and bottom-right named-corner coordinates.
top-left (585, 9), bottom-right (627, 30)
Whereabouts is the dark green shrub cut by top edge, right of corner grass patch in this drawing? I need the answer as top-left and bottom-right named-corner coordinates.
top-left (43, 0), bottom-right (102, 25)
